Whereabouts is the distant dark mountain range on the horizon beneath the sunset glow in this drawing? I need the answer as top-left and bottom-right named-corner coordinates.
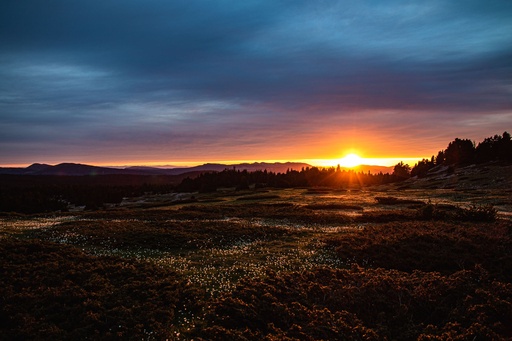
top-left (0, 162), bottom-right (393, 176)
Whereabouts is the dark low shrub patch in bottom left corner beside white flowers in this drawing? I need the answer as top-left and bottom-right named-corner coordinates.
top-left (0, 238), bottom-right (202, 340)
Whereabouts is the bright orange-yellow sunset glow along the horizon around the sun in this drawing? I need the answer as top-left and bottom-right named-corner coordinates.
top-left (0, 123), bottom-right (432, 169)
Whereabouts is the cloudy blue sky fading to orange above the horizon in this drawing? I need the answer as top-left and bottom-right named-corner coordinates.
top-left (0, 0), bottom-right (512, 166)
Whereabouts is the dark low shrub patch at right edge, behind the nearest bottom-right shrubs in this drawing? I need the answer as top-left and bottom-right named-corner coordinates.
top-left (324, 221), bottom-right (512, 282)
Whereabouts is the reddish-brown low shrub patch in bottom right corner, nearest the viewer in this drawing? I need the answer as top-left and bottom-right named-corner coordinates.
top-left (192, 266), bottom-right (512, 340)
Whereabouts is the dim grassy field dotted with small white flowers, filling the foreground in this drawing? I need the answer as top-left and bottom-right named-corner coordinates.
top-left (0, 186), bottom-right (512, 340)
